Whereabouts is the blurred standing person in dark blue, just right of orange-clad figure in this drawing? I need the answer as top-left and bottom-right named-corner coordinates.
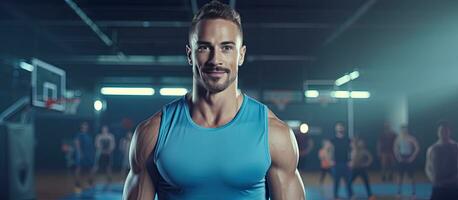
top-left (331, 122), bottom-right (353, 199)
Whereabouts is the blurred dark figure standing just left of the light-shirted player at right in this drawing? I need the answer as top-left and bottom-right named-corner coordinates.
top-left (377, 123), bottom-right (396, 181)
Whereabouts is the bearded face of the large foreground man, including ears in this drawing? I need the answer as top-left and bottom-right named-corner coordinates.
top-left (186, 19), bottom-right (246, 93)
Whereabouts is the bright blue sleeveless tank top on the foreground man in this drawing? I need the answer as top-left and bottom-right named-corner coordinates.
top-left (148, 95), bottom-right (271, 200)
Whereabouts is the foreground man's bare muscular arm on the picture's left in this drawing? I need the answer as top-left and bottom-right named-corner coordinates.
top-left (122, 112), bottom-right (162, 200)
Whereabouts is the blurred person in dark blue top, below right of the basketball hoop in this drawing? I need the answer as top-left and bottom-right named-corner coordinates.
top-left (73, 122), bottom-right (94, 193)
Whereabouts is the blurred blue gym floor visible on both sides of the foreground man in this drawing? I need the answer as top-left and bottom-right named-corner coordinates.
top-left (35, 171), bottom-right (431, 200)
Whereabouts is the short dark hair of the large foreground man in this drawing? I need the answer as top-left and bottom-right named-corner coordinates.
top-left (188, 0), bottom-right (243, 41)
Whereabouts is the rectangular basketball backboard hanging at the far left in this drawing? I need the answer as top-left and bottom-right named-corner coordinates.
top-left (32, 58), bottom-right (65, 111)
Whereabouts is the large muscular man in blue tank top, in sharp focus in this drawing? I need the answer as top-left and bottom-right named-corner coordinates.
top-left (123, 1), bottom-right (304, 200)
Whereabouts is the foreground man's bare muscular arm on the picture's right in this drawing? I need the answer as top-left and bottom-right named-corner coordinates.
top-left (267, 112), bottom-right (305, 200)
